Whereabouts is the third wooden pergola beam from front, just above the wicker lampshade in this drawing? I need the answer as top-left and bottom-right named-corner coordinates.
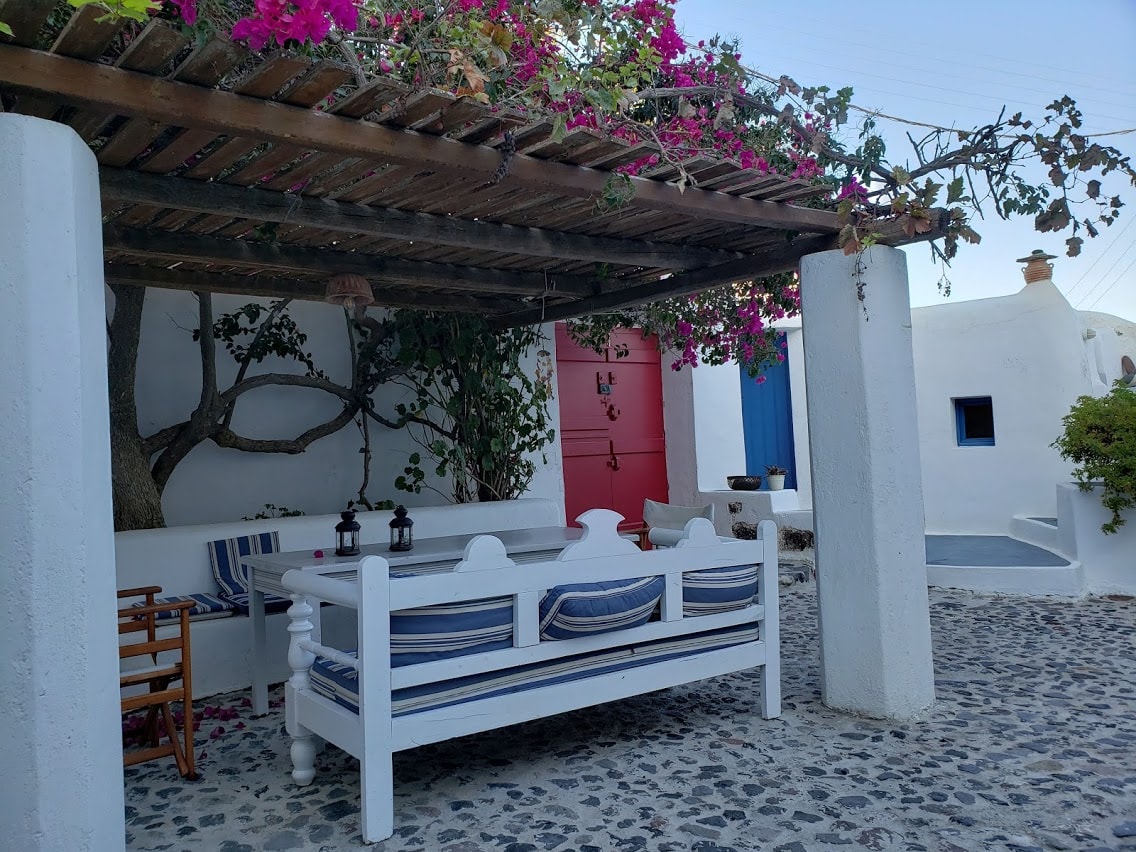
top-left (102, 224), bottom-right (600, 298)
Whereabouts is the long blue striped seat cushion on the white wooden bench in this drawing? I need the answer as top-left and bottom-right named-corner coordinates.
top-left (311, 624), bottom-right (758, 717)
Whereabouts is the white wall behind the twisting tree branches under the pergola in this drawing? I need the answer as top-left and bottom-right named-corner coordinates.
top-left (119, 289), bottom-right (563, 526)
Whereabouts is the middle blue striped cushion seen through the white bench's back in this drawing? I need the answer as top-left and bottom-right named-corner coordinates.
top-left (540, 577), bottom-right (666, 640)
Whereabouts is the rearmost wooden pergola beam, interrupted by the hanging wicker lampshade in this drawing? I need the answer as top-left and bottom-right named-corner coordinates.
top-left (103, 264), bottom-right (517, 315)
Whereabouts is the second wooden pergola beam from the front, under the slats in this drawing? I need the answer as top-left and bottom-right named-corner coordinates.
top-left (99, 168), bottom-right (744, 269)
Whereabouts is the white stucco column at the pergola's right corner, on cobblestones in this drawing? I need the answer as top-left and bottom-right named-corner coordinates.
top-left (801, 247), bottom-right (935, 719)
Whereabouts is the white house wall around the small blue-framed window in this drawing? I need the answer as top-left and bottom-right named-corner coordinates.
top-left (911, 281), bottom-right (1119, 534)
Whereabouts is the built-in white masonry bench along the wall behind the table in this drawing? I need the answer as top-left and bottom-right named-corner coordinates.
top-left (115, 498), bottom-right (565, 699)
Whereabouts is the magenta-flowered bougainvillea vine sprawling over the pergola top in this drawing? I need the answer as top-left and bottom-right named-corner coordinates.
top-left (77, 0), bottom-right (1136, 367)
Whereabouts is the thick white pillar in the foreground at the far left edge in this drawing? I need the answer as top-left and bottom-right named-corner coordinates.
top-left (0, 115), bottom-right (125, 852)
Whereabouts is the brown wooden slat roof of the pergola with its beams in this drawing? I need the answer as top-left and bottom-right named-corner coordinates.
top-left (0, 0), bottom-right (942, 324)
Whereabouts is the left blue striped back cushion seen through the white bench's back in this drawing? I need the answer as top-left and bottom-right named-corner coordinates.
top-left (391, 598), bottom-right (512, 667)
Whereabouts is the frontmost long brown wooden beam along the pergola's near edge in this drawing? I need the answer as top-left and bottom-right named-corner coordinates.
top-left (0, 44), bottom-right (840, 233)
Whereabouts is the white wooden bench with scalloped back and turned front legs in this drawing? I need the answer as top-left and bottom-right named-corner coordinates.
top-left (283, 509), bottom-right (780, 842)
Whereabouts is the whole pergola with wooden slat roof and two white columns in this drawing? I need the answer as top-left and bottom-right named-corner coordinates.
top-left (0, 0), bottom-right (944, 852)
